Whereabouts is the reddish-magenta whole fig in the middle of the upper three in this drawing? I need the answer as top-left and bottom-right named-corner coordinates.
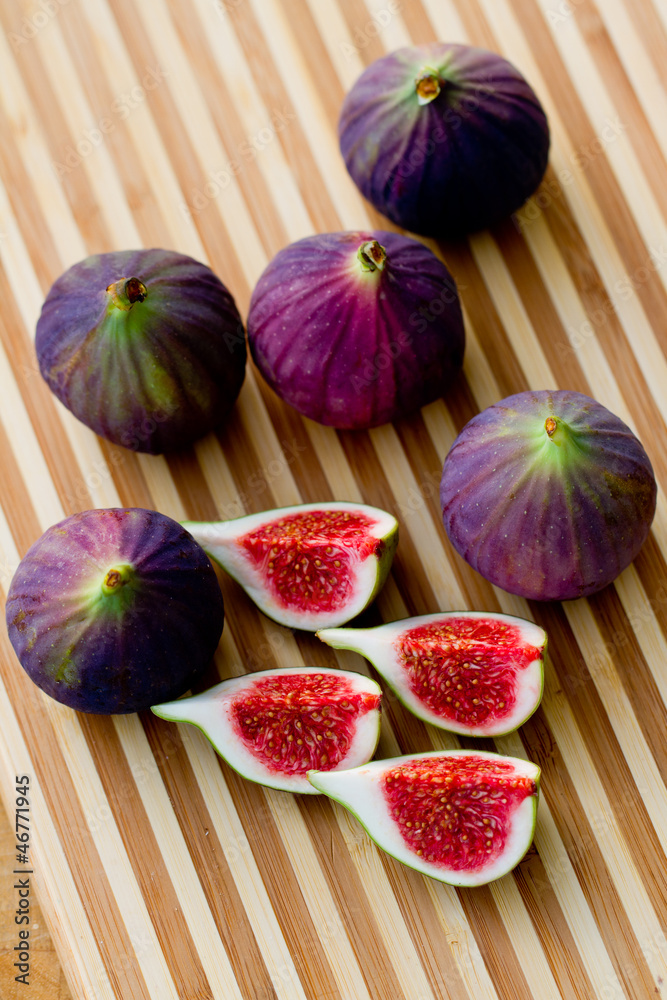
top-left (248, 231), bottom-right (465, 430)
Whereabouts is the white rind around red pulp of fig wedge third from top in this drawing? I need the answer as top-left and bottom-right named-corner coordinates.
top-left (151, 667), bottom-right (382, 795)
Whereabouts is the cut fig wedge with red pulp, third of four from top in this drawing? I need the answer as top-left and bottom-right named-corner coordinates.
top-left (153, 667), bottom-right (382, 795)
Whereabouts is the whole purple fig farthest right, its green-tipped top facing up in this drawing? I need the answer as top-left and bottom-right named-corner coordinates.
top-left (440, 390), bottom-right (657, 601)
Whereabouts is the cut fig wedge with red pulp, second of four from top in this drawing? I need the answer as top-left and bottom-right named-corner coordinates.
top-left (317, 611), bottom-right (547, 736)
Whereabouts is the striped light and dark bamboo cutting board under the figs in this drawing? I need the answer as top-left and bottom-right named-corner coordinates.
top-left (0, 0), bottom-right (667, 1000)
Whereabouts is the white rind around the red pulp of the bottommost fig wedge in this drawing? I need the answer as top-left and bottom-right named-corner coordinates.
top-left (308, 750), bottom-right (540, 886)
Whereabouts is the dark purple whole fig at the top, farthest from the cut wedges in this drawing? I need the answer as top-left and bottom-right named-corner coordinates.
top-left (338, 42), bottom-right (549, 238)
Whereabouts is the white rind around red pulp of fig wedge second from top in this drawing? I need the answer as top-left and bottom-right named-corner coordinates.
top-left (317, 611), bottom-right (547, 737)
